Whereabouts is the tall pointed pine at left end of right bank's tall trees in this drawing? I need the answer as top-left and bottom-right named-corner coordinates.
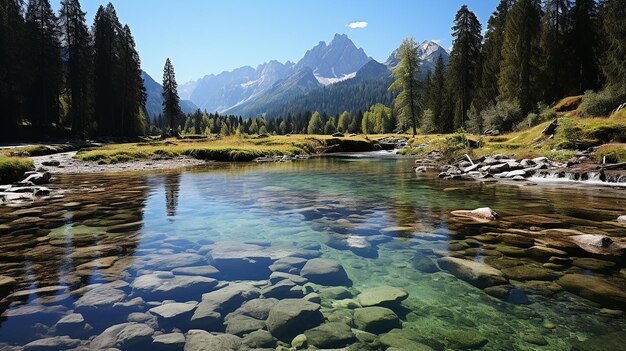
top-left (448, 5), bottom-right (482, 129)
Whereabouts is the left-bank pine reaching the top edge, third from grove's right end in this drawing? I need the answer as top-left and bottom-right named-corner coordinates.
top-left (60, 0), bottom-right (93, 138)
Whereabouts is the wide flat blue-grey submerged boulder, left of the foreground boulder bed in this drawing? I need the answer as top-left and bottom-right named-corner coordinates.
top-left (131, 272), bottom-right (217, 301)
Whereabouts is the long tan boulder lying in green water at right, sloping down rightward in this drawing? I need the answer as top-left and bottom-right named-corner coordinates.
top-left (439, 257), bottom-right (507, 289)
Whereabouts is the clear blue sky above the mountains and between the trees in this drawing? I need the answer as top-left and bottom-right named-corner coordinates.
top-left (56, 0), bottom-right (498, 84)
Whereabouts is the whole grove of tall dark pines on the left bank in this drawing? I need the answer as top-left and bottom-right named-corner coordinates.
top-left (0, 0), bottom-right (147, 140)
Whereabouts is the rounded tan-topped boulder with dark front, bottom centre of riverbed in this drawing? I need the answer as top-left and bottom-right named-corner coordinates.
top-left (267, 299), bottom-right (324, 341)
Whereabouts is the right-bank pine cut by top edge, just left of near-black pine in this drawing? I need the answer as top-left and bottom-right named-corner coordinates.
top-left (540, 0), bottom-right (570, 103)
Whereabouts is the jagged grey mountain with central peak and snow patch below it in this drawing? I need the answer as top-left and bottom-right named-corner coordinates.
top-left (179, 34), bottom-right (371, 114)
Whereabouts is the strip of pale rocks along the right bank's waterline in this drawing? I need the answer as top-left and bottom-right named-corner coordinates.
top-left (415, 152), bottom-right (626, 186)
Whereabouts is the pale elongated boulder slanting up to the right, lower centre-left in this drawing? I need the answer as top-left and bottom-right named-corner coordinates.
top-left (191, 283), bottom-right (260, 328)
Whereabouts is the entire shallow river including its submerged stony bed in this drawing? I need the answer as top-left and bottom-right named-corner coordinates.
top-left (0, 157), bottom-right (626, 350)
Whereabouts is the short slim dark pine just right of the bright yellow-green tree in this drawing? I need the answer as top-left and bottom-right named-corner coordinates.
top-left (425, 55), bottom-right (452, 133)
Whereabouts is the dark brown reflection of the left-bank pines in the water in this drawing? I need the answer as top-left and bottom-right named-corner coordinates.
top-left (0, 175), bottom-right (149, 320)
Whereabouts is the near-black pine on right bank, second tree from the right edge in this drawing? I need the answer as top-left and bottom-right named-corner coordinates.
top-left (567, 0), bottom-right (601, 94)
